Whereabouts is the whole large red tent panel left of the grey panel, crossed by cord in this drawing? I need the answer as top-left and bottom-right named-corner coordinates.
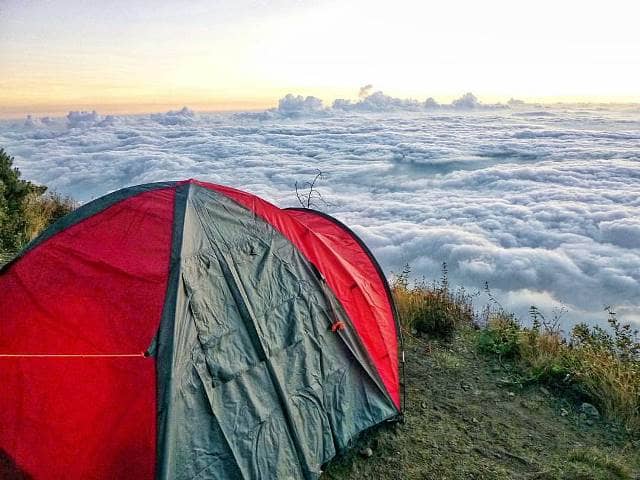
top-left (0, 188), bottom-right (175, 479)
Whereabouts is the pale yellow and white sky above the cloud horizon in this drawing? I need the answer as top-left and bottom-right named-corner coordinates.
top-left (0, 0), bottom-right (640, 117)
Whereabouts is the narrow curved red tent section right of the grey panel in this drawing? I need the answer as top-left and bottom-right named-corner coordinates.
top-left (191, 182), bottom-right (400, 408)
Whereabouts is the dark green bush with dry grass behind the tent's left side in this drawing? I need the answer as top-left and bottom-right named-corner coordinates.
top-left (0, 148), bottom-right (75, 264)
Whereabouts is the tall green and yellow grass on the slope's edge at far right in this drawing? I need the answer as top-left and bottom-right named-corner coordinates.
top-left (478, 313), bottom-right (640, 436)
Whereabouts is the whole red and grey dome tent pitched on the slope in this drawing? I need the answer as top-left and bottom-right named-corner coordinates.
top-left (0, 180), bottom-right (402, 480)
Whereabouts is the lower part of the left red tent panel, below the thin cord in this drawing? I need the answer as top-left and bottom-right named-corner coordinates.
top-left (0, 356), bottom-right (156, 480)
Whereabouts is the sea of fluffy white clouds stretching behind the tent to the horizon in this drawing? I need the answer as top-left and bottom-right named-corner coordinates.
top-left (0, 91), bottom-right (640, 328)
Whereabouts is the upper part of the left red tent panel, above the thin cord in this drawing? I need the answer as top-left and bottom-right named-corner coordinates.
top-left (0, 189), bottom-right (175, 354)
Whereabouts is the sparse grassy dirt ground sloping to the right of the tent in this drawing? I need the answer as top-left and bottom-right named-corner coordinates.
top-left (323, 330), bottom-right (640, 480)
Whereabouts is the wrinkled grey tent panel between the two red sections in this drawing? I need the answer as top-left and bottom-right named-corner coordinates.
top-left (155, 184), bottom-right (398, 480)
